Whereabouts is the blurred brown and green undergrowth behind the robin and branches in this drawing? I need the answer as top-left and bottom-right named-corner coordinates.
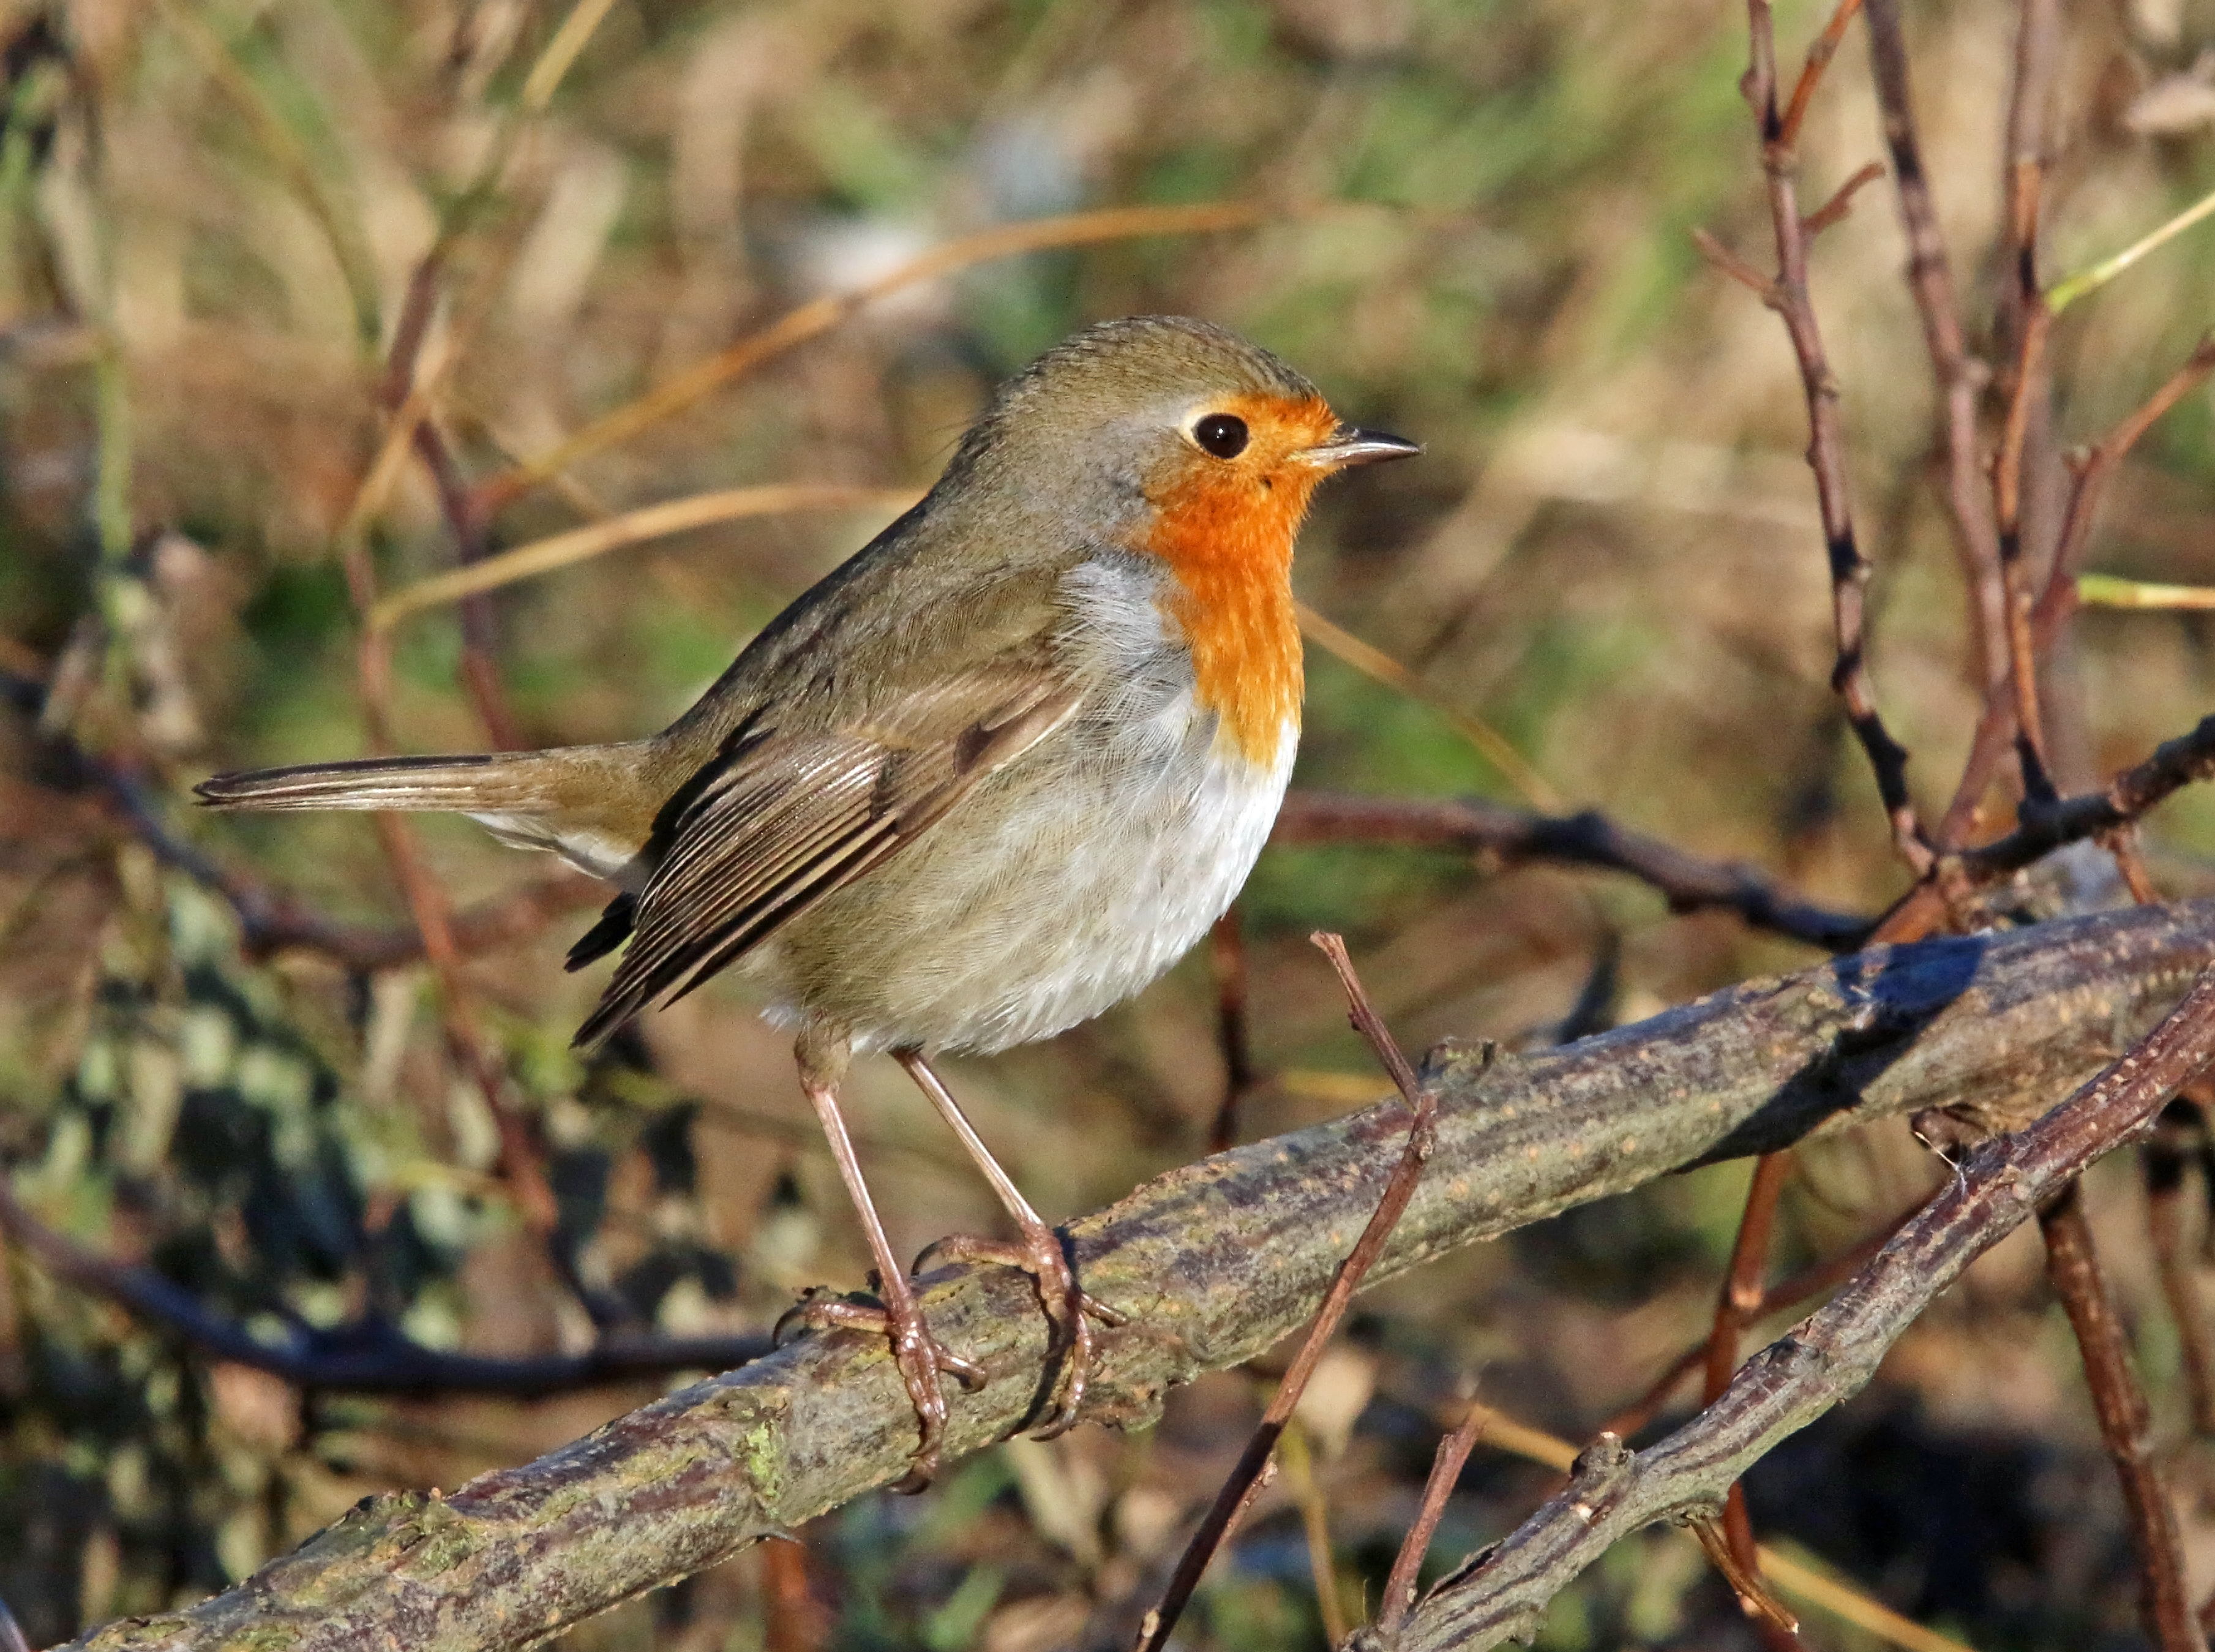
top-left (0, 0), bottom-right (2215, 1652)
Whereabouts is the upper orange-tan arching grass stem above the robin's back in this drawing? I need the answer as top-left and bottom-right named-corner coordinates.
top-left (478, 201), bottom-right (1272, 518)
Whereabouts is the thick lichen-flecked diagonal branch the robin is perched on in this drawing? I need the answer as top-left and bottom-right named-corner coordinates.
top-left (56, 904), bottom-right (2215, 1652)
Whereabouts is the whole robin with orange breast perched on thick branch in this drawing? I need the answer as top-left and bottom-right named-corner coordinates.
top-left (200, 317), bottom-right (1420, 1486)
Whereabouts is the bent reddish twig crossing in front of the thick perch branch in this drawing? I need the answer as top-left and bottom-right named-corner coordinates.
top-left (1139, 930), bottom-right (1437, 1652)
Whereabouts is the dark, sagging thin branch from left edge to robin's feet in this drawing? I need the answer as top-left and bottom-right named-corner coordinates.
top-left (0, 1174), bottom-right (773, 1400)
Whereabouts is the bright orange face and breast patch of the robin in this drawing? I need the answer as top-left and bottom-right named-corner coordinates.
top-left (1147, 394), bottom-right (1338, 764)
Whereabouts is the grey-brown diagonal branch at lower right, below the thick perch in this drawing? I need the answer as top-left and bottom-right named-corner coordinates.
top-left (1400, 974), bottom-right (2215, 1652)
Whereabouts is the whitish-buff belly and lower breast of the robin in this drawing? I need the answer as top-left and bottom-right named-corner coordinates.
top-left (755, 547), bottom-right (1298, 1052)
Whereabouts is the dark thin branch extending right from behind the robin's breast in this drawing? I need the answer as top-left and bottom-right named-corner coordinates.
top-left (1269, 790), bottom-right (1872, 950)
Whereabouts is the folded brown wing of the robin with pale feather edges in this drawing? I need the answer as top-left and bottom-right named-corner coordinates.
top-left (571, 662), bottom-right (1076, 1049)
